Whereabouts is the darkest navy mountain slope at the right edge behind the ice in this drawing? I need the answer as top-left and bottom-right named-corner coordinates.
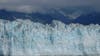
top-left (74, 12), bottom-right (100, 25)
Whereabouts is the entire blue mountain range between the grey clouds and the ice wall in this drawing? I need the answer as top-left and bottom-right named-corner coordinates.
top-left (0, 7), bottom-right (100, 25)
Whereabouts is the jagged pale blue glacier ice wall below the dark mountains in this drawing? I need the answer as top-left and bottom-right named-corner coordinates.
top-left (0, 19), bottom-right (100, 56)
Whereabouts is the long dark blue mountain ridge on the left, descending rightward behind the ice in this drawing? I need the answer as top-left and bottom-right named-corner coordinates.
top-left (0, 10), bottom-right (70, 24)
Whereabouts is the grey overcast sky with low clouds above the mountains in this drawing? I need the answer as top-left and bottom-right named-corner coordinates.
top-left (0, 0), bottom-right (100, 12)
